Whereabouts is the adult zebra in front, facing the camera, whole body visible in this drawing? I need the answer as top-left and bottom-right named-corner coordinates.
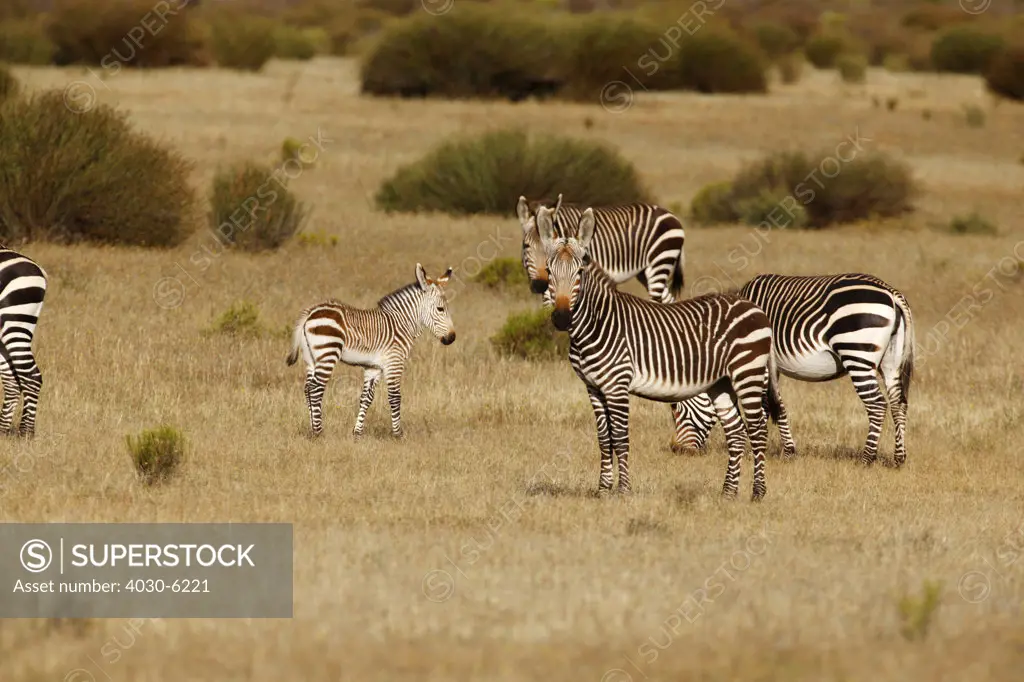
top-left (537, 207), bottom-right (779, 501)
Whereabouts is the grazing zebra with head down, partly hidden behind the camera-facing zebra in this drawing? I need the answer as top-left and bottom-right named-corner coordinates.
top-left (674, 273), bottom-right (913, 467)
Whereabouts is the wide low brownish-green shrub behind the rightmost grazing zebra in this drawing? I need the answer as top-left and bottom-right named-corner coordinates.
top-left (691, 152), bottom-right (915, 228)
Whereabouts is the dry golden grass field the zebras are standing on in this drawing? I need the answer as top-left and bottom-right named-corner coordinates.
top-left (0, 58), bottom-right (1024, 682)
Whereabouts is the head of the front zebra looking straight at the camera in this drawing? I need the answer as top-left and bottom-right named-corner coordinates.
top-left (537, 206), bottom-right (594, 332)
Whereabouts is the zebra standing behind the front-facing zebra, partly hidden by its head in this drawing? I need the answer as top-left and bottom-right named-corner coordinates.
top-left (516, 195), bottom-right (685, 303)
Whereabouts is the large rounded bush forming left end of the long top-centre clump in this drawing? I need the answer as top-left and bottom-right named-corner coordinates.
top-left (361, 5), bottom-right (557, 99)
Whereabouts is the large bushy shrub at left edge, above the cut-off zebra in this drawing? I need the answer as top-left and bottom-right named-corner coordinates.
top-left (0, 91), bottom-right (195, 246)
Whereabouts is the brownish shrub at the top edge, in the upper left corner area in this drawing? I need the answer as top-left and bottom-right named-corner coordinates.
top-left (47, 0), bottom-right (204, 70)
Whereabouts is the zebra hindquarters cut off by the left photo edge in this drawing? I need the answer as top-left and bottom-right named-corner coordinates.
top-left (0, 249), bottom-right (46, 436)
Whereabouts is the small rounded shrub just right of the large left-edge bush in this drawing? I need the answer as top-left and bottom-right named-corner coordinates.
top-left (209, 163), bottom-right (306, 251)
